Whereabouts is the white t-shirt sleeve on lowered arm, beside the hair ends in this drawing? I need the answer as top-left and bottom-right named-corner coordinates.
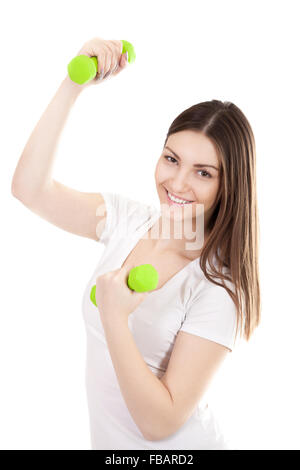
top-left (180, 283), bottom-right (237, 352)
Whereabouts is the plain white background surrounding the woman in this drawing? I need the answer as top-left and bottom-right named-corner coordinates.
top-left (0, 0), bottom-right (300, 449)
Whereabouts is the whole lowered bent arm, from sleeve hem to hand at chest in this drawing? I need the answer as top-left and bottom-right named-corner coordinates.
top-left (96, 268), bottom-right (231, 441)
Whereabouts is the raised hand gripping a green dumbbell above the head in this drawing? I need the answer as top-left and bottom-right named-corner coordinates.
top-left (77, 37), bottom-right (128, 87)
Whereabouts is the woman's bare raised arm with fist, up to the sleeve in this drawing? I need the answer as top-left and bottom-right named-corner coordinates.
top-left (11, 38), bottom-right (126, 241)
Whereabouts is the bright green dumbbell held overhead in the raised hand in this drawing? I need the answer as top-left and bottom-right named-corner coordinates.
top-left (68, 39), bottom-right (135, 85)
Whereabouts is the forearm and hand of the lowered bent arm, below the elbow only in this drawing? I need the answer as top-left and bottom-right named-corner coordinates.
top-left (96, 267), bottom-right (173, 440)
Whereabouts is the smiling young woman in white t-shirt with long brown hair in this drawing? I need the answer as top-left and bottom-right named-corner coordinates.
top-left (12, 38), bottom-right (260, 450)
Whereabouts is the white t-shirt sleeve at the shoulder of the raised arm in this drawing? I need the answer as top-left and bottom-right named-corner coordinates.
top-left (96, 191), bottom-right (149, 246)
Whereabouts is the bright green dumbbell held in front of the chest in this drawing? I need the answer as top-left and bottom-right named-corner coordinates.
top-left (90, 264), bottom-right (158, 307)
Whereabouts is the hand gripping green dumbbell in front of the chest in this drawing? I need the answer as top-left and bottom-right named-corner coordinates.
top-left (96, 266), bottom-right (147, 321)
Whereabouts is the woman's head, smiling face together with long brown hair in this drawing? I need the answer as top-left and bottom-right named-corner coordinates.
top-left (155, 100), bottom-right (261, 340)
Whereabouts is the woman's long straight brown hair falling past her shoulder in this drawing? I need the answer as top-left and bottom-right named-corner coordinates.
top-left (164, 100), bottom-right (261, 341)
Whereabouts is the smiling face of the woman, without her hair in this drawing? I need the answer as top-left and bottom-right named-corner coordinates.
top-left (155, 130), bottom-right (220, 227)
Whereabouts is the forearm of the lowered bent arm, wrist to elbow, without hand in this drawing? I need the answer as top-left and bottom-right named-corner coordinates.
top-left (103, 312), bottom-right (173, 441)
